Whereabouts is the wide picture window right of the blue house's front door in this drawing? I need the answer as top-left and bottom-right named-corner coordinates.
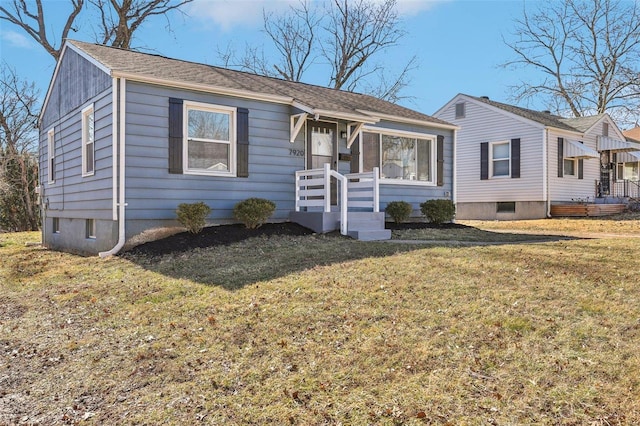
top-left (362, 131), bottom-right (436, 184)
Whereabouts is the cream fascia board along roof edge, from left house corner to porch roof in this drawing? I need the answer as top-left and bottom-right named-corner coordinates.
top-left (113, 71), bottom-right (294, 105)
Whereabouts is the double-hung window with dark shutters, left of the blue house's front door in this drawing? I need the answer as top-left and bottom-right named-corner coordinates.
top-left (183, 102), bottom-right (236, 176)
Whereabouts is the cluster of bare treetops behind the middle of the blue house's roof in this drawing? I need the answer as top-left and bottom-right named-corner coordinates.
top-left (218, 0), bottom-right (417, 101)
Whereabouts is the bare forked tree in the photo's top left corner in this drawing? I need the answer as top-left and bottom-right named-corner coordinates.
top-left (0, 0), bottom-right (84, 61)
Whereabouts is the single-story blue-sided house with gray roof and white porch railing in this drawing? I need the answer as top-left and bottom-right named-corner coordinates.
top-left (40, 41), bottom-right (457, 255)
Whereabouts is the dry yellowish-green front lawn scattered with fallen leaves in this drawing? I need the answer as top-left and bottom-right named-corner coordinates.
top-left (0, 219), bottom-right (640, 425)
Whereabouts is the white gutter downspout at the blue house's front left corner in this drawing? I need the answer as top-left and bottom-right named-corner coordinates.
top-left (98, 78), bottom-right (127, 258)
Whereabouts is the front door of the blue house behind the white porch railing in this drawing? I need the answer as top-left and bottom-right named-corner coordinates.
top-left (307, 120), bottom-right (338, 205)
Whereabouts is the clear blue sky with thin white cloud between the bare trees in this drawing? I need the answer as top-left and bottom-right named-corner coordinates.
top-left (0, 0), bottom-right (546, 114)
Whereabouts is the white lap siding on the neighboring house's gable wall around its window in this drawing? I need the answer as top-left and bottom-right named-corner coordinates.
top-left (438, 101), bottom-right (544, 203)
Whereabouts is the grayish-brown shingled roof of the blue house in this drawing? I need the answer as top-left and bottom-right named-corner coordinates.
top-left (68, 40), bottom-right (453, 126)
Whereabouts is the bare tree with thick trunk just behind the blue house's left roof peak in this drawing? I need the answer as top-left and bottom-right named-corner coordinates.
top-left (89, 0), bottom-right (193, 49)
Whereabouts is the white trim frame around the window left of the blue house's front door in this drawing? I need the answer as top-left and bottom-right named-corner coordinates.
top-left (182, 101), bottom-right (238, 177)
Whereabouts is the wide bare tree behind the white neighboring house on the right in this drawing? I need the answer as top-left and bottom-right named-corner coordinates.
top-left (503, 0), bottom-right (640, 121)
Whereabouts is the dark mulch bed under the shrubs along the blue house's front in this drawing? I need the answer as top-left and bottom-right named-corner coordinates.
top-left (123, 222), bottom-right (465, 257)
